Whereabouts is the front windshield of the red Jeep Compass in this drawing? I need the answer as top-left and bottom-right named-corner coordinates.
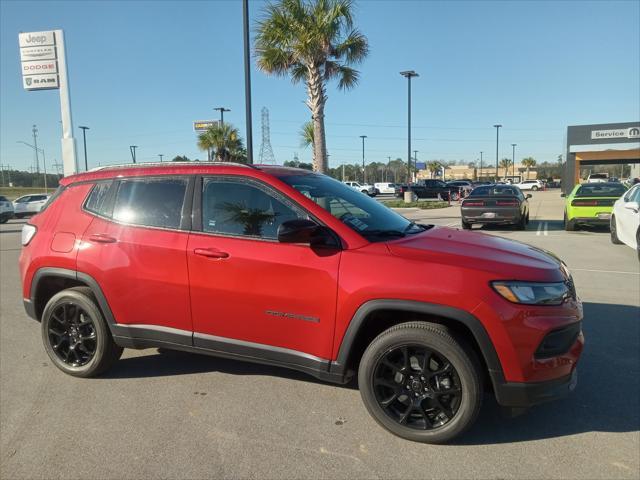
top-left (278, 174), bottom-right (425, 241)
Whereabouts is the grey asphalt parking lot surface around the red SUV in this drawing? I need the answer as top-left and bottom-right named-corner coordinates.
top-left (0, 191), bottom-right (640, 479)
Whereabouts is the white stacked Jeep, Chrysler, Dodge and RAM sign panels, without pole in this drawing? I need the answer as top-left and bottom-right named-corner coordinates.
top-left (18, 31), bottom-right (60, 90)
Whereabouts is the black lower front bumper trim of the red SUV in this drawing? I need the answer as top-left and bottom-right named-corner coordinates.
top-left (494, 369), bottom-right (578, 408)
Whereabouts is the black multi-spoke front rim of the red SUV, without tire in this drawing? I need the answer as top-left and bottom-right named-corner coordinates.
top-left (373, 345), bottom-right (462, 430)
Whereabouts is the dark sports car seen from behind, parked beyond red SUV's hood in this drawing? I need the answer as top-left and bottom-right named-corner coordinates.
top-left (460, 184), bottom-right (531, 230)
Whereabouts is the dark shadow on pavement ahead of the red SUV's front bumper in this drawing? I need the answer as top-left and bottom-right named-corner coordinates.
top-left (455, 303), bottom-right (640, 445)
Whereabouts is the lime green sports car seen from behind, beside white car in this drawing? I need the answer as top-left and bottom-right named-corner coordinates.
top-left (562, 182), bottom-right (627, 231)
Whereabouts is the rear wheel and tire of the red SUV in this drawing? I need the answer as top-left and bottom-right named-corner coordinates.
top-left (41, 287), bottom-right (123, 377)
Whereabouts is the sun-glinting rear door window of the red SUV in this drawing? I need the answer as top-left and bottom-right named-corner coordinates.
top-left (113, 177), bottom-right (188, 229)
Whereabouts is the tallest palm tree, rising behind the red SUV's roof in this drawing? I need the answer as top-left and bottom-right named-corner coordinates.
top-left (255, 0), bottom-right (369, 173)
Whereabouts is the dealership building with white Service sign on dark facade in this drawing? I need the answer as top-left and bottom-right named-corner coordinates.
top-left (562, 122), bottom-right (640, 193)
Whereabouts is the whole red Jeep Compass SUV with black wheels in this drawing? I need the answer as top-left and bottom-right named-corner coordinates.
top-left (20, 163), bottom-right (583, 443)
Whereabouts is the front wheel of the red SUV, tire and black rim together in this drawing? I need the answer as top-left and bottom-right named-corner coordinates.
top-left (358, 322), bottom-right (483, 443)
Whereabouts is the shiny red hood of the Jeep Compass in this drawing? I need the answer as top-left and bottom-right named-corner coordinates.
top-left (387, 226), bottom-right (565, 282)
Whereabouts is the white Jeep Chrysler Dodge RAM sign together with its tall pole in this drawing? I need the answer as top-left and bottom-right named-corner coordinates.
top-left (18, 30), bottom-right (78, 176)
